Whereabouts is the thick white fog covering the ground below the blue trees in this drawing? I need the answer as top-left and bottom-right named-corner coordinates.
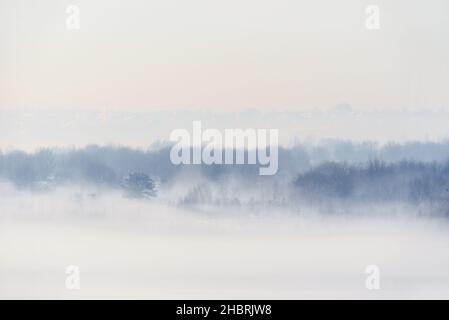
top-left (0, 184), bottom-right (449, 299)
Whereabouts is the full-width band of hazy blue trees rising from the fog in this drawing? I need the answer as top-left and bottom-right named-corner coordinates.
top-left (0, 141), bottom-right (449, 215)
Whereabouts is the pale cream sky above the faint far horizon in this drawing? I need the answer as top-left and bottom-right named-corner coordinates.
top-left (0, 0), bottom-right (449, 111)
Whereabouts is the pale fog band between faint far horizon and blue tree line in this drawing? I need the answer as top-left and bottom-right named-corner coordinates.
top-left (4, 109), bottom-right (449, 151)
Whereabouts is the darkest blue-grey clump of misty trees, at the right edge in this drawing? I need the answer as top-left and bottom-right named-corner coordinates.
top-left (294, 160), bottom-right (449, 208)
